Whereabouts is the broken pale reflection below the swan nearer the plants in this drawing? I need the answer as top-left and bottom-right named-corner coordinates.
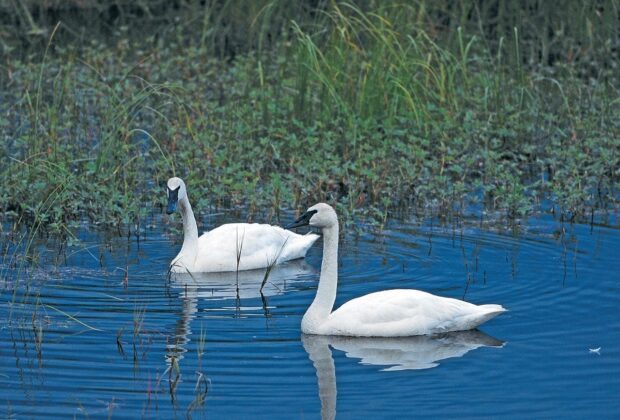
top-left (166, 259), bottom-right (316, 362)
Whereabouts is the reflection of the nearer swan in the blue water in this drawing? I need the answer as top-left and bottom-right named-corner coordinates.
top-left (301, 330), bottom-right (505, 419)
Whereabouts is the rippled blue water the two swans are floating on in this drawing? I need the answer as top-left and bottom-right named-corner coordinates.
top-left (0, 216), bottom-right (620, 419)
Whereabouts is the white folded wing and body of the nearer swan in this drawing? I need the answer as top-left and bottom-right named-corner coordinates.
top-left (325, 289), bottom-right (494, 337)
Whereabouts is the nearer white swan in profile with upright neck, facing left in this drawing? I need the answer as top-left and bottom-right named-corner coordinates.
top-left (286, 203), bottom-right (505, 337)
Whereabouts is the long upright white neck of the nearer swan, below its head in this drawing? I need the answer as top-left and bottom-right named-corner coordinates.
top-left (304, 224), bottom-right (338, 323)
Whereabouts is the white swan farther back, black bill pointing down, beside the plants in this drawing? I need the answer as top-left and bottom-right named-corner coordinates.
top-left (166, 177), bottom-right (318, 273)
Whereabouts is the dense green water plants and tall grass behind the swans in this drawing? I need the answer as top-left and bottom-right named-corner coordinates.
top-left (0, 0), bottom-right (620, 230)
